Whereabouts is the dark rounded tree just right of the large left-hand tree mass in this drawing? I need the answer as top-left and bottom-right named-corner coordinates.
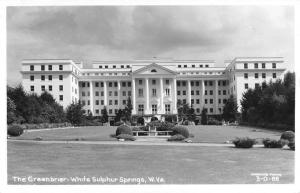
top-left (66, 102), bottom-right (85, 125)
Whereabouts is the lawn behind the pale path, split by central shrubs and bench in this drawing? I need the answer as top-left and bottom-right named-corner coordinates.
top-left (14, 125), bottom-right (281, 143)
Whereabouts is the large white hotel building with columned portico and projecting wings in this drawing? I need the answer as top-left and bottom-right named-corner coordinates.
top-left (21, 57), bottom-right (285, 118)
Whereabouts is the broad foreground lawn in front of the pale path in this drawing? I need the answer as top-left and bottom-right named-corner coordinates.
top-left (8, 141), bottom-right (294, 184)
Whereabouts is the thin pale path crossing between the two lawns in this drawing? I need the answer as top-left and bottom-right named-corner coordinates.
top-left (7, 139), bottom-right (263, 147)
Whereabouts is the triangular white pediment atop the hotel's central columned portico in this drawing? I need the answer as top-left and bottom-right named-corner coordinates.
top-left (133, 63), bottom-right (177, 75)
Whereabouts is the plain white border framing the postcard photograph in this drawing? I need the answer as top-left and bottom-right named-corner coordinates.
top-left (0, 0), bottom-right (300, 193)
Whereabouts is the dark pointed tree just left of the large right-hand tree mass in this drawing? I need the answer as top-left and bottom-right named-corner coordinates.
top-left (222, 95), bottom-right (238, 122)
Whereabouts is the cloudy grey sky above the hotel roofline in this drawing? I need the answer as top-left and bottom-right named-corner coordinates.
top-left (7, 5), bottom-right (294, 86)
